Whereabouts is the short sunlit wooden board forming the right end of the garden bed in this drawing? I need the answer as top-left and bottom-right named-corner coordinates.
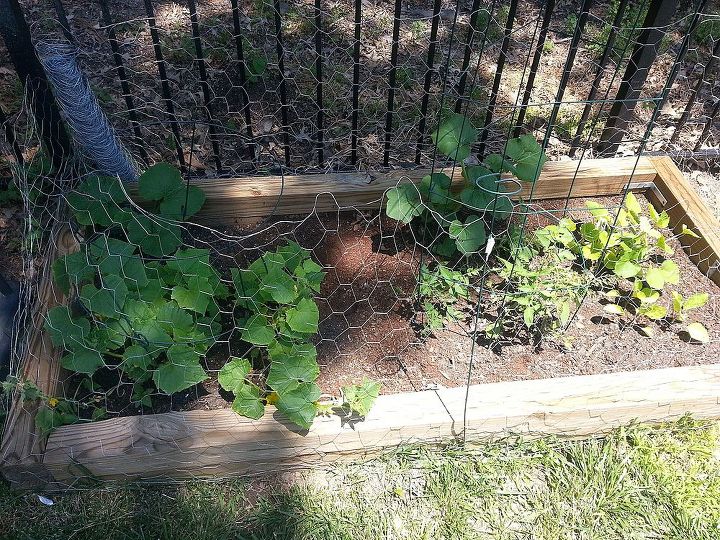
top-left (651, 157), bottom-right (720, 285)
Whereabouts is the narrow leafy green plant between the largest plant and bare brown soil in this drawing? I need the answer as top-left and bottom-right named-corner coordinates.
top-left (219, 243), bottom-right (325, 429)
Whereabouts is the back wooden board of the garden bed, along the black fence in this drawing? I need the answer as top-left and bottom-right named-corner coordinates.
top-left (130, 158), bottom-right (655, 223)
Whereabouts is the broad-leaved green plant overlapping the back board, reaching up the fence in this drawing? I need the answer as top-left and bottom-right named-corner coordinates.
top-left (386, 113), bottom-right (547, 257)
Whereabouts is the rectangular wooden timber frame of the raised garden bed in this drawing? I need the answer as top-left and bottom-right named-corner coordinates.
top-left (0, 154), bottom-right (720, 486)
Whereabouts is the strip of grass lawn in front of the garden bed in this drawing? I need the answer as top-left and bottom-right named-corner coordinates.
top-left (0, 419), bottom-right (720, 540)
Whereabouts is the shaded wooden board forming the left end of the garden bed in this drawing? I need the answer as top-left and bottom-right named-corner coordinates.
top-left (0, 228), bottom-right (78, 487)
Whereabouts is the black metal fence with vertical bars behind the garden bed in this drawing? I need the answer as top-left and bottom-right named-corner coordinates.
top-left (0, 0), bottom-right (720, 176)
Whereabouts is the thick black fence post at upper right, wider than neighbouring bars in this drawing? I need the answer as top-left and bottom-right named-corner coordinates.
top-left (597, 0), bottom-right (678, 157)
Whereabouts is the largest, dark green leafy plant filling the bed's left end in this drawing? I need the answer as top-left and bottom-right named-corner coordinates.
top-left (45, 164), bottom-right (224, 406)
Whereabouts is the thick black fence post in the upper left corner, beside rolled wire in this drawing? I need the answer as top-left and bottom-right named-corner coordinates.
top-left (0, 0), bottom-right (71, 169)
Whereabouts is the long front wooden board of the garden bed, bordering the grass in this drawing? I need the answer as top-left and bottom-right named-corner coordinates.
top-left (44, 364), bottom-right (720, 483)
